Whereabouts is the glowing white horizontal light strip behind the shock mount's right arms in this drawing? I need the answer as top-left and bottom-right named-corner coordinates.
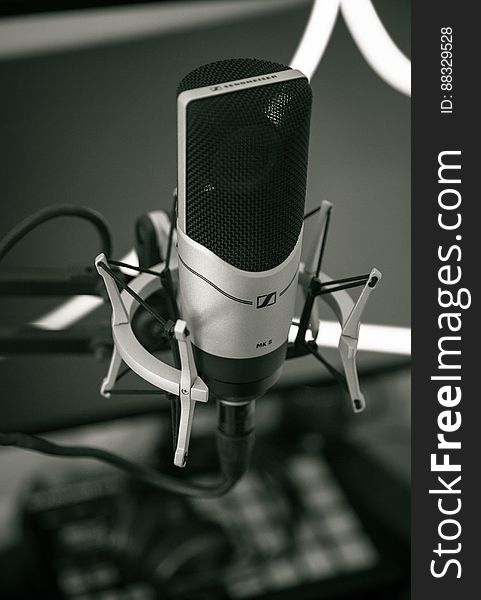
top-left (316, 321), bottom-right (411, 356)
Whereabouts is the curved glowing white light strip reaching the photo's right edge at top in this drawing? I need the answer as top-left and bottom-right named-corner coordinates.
top-left (341, 0), bottom-right (411, 96)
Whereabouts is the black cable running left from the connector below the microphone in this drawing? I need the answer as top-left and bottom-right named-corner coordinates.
top-left (0, 433), bottom-right (238, 498)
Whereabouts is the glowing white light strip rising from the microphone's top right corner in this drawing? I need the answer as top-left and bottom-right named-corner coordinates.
top-left (290, 0), bottom-right (339, 79)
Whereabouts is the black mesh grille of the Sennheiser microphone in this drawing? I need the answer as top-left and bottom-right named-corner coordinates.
top-left (179, 59), bottom-right (311, 272)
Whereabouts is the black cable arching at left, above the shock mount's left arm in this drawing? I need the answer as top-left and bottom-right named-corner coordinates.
top-left (0, 204), bottom-right (112, 260)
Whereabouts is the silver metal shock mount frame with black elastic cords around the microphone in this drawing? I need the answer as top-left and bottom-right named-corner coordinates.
top-left (95, 200), bottom-right (382, 467)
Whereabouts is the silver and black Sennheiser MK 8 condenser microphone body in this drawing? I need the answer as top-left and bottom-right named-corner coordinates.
top-left (177, 59), bottom-right (312, 401)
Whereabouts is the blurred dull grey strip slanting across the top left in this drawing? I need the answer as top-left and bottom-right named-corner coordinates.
top-left (0, 0), bottom-right (306, 58)
